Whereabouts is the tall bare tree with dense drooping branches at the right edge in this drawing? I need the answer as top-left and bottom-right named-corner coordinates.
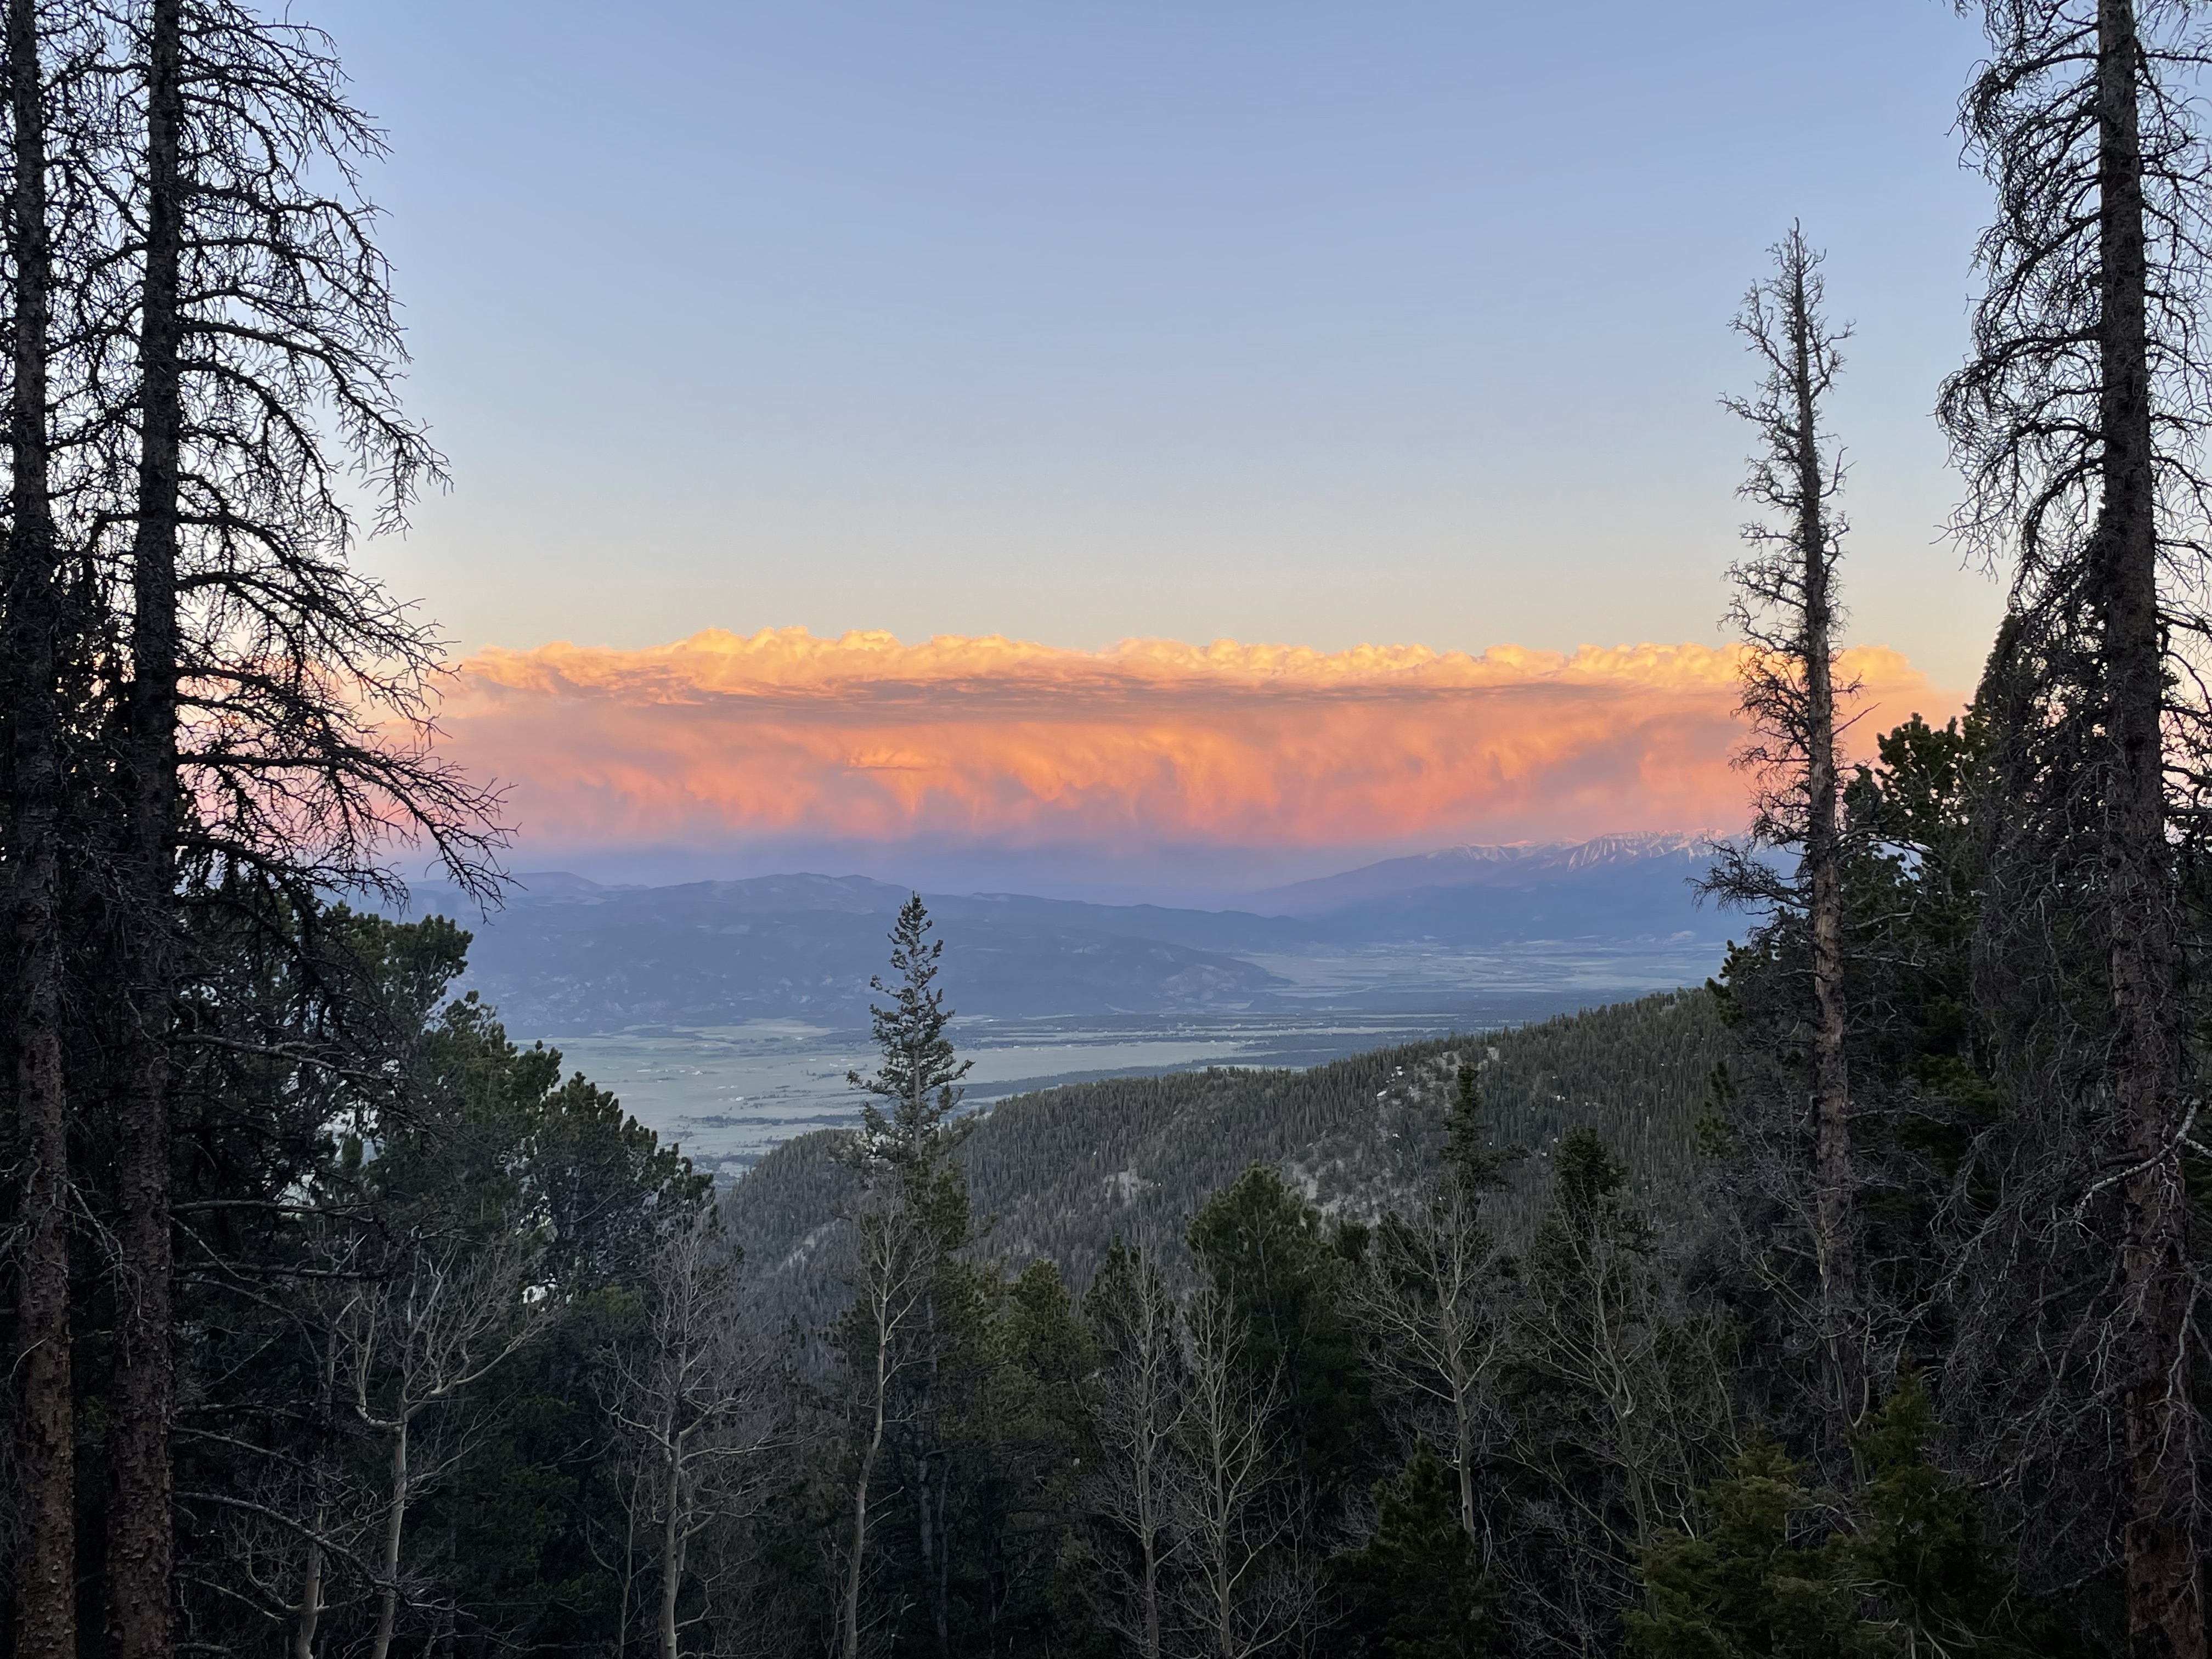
top-left (1942, 0), bottom-right (2212, 1659)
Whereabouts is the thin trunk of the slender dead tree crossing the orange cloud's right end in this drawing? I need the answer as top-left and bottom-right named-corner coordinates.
top-left (1787, 236), bottom-right (1867, 1429)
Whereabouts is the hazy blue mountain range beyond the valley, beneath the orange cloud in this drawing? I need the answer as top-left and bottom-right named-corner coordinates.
top-left (398, 836), bottom-right (1721, 1035)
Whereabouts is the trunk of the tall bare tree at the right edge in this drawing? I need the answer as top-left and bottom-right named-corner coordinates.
top-left (2088, 0), bottom-right (2205, 1659)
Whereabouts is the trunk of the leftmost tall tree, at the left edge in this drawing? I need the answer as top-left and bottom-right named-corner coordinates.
top-left (0, 0), bottom-right (77, 1659)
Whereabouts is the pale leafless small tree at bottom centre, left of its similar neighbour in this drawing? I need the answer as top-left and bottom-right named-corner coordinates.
top-left (1084, 1243), bottom-right (1188, 1659)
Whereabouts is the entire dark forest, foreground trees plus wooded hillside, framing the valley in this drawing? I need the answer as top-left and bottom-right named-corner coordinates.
top-left (0, 0), bottom-right (2212, 1659)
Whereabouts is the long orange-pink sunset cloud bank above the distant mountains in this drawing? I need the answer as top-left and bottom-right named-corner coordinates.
top-left (442, 628), bottom-right (1951, 847)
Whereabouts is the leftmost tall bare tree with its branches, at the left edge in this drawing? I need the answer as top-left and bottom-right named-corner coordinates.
top-left (0, 0), bottom-right (119, 1659)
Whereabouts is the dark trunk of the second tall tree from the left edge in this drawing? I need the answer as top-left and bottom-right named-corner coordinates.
top-left (109, 0), bottom-right (182, 1659)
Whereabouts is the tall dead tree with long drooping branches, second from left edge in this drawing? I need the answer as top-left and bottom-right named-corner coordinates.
top-left (83, 0), bottom-right (495, 1659)
